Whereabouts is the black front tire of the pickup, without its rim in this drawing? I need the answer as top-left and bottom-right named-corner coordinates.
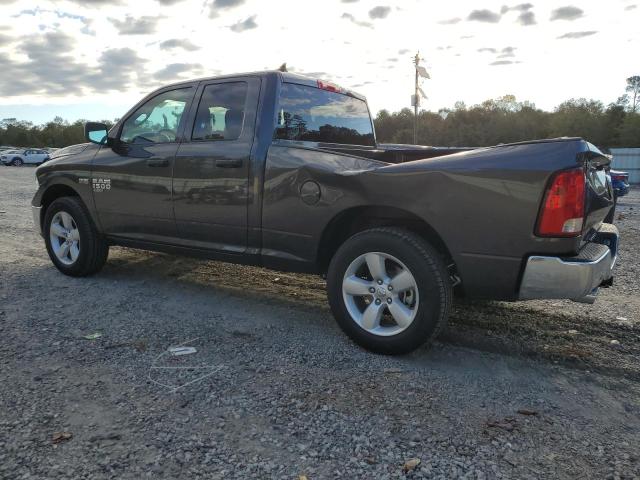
top-left (43, 197), bottom-right (109, 277)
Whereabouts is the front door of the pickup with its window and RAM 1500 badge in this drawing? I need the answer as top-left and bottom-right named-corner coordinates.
top-left (90, 86), bottom-right (195, 241)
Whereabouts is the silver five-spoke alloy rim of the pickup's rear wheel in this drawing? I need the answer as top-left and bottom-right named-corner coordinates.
top-left (342, 252), bottom-right (420, 337)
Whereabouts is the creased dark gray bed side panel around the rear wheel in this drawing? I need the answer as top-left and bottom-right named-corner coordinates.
top-left (263, 140), bottom-right (586, 298)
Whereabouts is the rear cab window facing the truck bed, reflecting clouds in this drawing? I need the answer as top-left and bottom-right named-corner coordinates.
top-left (274, 82), bottom-right (375, 147)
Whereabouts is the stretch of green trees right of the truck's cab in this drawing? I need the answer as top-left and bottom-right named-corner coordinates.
top-left (375, 95), bottom-right (640, 149)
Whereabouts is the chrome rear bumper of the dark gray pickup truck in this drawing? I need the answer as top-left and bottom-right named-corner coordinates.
top-left (519, 224), bottom-right (618, 303)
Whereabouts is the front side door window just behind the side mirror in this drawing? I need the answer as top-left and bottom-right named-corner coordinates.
top-left (120, 88), bottom-right (192, 143)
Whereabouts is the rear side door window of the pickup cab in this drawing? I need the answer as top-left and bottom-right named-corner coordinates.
top-left (191, 82), bottom-right (247, 140)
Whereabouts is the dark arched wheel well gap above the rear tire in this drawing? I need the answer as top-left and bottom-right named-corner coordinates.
top-left (317, 207), bottom-right (455, 274)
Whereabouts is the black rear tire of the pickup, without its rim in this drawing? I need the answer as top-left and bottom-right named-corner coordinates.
top-left (327, 227), bottom-right (452, 355)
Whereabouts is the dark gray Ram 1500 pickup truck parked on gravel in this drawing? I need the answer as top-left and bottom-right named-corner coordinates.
top-left (33, 72), bottom-right (618, 353)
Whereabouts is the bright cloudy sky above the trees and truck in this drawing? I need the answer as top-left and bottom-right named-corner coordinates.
top-left (0, 0), bottom-right (640, 124)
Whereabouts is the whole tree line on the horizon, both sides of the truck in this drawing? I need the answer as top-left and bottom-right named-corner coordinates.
top-left (0, 76), bottom-right (640, 149)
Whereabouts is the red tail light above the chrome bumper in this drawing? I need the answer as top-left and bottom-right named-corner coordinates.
top-left (536, 168), bottom-right (585, 237)
